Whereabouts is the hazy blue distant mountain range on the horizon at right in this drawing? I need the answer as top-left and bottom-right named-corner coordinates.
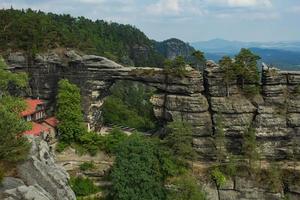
top-left (191, 39), bottom-right (300, 70)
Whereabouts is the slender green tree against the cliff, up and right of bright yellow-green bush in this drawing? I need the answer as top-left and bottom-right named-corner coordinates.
top-left (242, 127), bottom-right (259, 169)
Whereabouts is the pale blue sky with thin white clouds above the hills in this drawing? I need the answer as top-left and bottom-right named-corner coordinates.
top-left (0, 0), bottom-right (300, 42)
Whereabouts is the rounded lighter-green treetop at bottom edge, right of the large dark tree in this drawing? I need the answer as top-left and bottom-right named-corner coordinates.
top-left (167, 174), bottom-right (207, 200)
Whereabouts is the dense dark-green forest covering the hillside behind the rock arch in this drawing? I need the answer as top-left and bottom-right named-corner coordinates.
top-left (0, 8), bottom-right (164, 66)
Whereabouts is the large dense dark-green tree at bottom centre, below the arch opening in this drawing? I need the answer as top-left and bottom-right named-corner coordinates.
top-left (111, 135), bottom-right (165, 200)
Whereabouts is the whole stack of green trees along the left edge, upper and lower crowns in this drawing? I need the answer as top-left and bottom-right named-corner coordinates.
top-left (0, 57), bottom-right (30, 161)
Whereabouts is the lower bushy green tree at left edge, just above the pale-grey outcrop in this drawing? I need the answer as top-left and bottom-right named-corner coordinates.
top-left (0, 96), bottom-right (30, 161)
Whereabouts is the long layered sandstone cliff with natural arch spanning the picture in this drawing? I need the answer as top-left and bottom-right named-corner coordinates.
top-left (8, 51), bottom-right (300, 159)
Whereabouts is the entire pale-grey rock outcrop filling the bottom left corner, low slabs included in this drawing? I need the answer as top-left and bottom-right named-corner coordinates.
top-left (0, 138), bottom-right (76, 200)
